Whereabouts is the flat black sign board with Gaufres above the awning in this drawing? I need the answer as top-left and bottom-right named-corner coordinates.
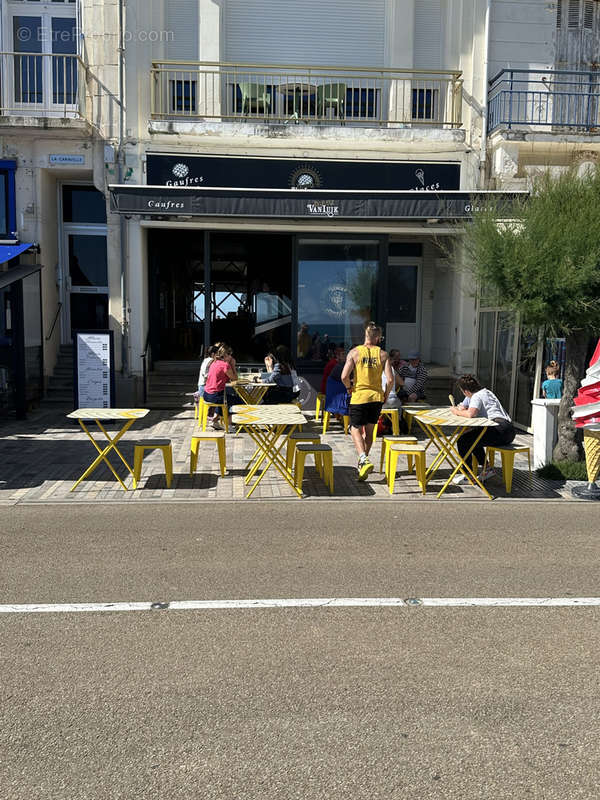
top-left (146, 153), bottom-right (460, 191)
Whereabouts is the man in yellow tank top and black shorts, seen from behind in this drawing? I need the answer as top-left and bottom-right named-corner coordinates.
top-left (342, 322), bottom-right (394, 481)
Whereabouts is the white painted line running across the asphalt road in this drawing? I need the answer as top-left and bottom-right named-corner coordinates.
top-left (0, 597), bottom-right (600, 614)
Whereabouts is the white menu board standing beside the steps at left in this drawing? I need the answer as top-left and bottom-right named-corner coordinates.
top-left (74, 331), bottom-right (115, 408)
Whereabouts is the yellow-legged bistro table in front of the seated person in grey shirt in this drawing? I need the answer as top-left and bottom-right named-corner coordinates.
top-left (406, 407), bottom-right (496, 500)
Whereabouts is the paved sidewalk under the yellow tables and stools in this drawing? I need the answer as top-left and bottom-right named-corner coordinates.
top-left (0, 409), bottom-right (570, 505)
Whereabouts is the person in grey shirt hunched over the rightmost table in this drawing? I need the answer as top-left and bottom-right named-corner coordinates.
top-left (452, 375), bottom-right (516, 483)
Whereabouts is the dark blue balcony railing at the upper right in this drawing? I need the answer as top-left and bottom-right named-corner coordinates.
top-left (488, 69), bottom-right (600, 133)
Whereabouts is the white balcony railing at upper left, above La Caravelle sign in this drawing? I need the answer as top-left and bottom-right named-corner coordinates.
top-left (0, 52), bottom-right (119, 138)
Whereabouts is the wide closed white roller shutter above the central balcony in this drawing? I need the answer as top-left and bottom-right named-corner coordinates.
top-left (224, 0), bottom-right (384, 67)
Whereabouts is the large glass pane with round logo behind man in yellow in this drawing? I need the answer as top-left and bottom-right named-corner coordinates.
top-left (298, 239), bottom-right (379, 359)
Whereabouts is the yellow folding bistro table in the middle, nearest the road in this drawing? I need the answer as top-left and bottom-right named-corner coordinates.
top-left (231, 403), bottom-right (306, 498)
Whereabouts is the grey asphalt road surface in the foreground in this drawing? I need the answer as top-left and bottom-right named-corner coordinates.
top-left (0, 501), bottom-right (600, 800)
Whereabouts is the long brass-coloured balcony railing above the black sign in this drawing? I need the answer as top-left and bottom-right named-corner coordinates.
top-left (151, 61), bottom-right (462, 128)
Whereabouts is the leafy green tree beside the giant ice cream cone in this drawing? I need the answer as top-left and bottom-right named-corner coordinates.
top-left (464, 169), bottom-right (600, 460)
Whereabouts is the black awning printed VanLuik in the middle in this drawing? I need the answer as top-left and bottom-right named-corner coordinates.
top-left (109, 185), bottom-right (527, 220)
